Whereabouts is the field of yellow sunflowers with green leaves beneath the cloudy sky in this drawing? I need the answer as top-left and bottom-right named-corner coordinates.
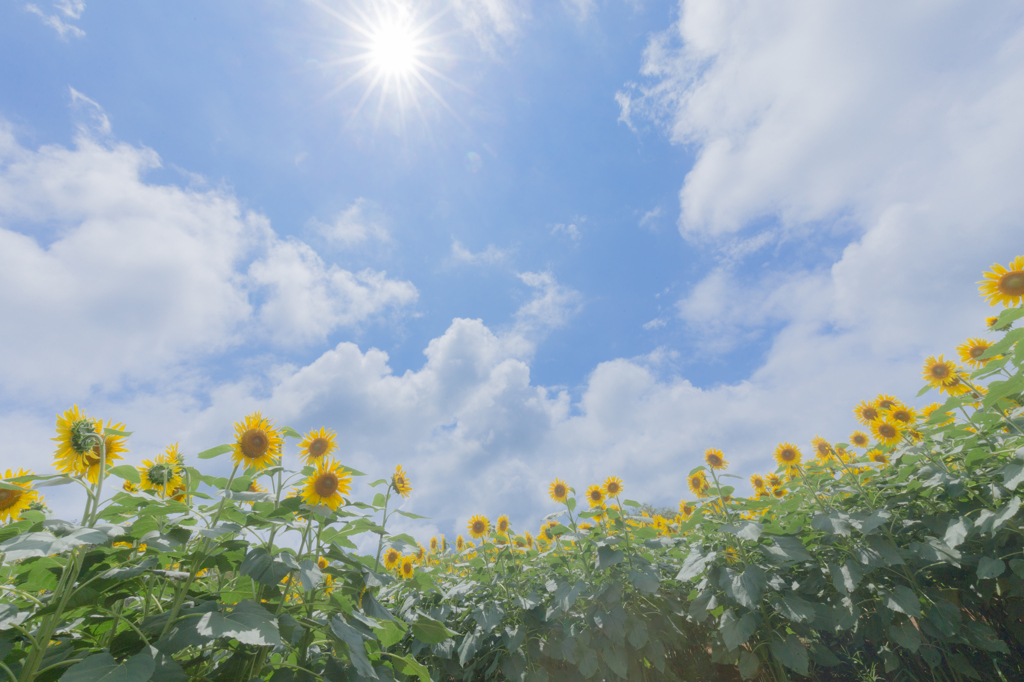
top-left (0, 257), bottom-right (1024, 682)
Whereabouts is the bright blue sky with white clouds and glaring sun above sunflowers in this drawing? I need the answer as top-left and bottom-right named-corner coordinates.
top-left (0, 0), bottom-right (1024, 539)
